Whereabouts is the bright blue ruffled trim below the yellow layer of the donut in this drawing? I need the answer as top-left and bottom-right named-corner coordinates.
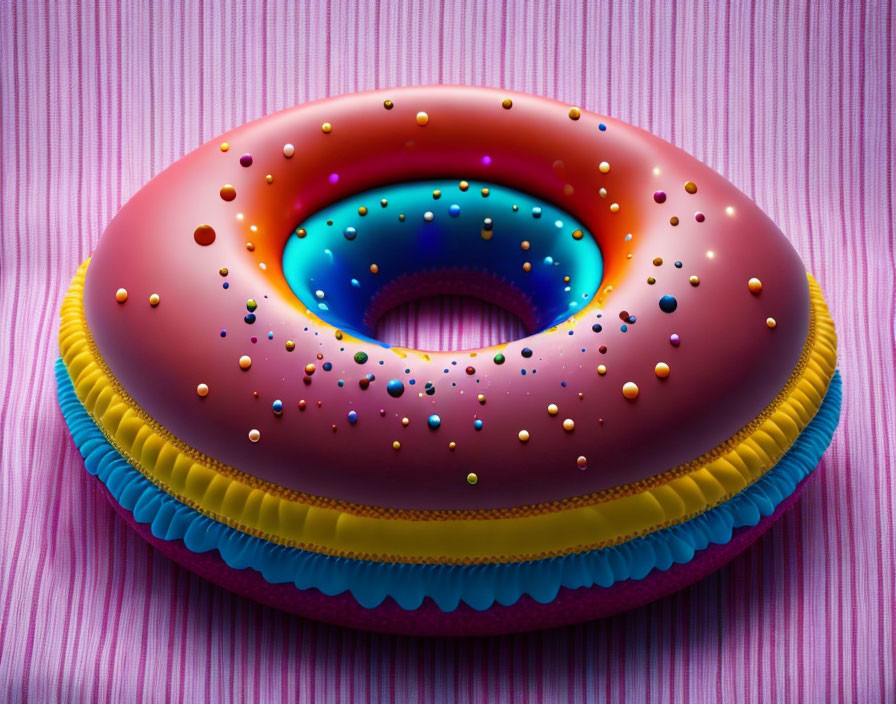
top-left (55, 359), bottom-right (842, 612)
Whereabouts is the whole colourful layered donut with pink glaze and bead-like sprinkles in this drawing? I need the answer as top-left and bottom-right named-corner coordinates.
top-left (56, 86), bottom-right (841, 635)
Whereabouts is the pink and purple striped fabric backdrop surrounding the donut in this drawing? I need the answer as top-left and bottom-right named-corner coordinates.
top-left (0, 0), bottom-right (896, 703)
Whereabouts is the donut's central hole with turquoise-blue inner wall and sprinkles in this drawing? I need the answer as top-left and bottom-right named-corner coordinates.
top-left (283, 181), bottom-right (603, 350)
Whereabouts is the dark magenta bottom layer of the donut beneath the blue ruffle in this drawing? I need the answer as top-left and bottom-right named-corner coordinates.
top-left (97, 473), bottom-right (814, 636)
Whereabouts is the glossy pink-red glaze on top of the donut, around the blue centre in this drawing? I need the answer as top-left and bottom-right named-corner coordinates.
top-left (84, 86), bottom-right (809, 508)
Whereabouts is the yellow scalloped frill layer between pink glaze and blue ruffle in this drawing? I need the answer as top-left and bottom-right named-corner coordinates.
top-left (59, 260), bottom-right (837, 564)
